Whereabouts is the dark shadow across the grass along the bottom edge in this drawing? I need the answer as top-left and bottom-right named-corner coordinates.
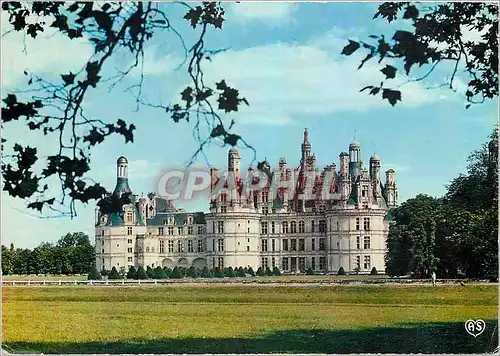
top-left (5, 320), bottom-right (498, 354)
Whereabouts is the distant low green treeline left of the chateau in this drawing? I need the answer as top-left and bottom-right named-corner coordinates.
top-left (2, 232), bottom-right (95, 276)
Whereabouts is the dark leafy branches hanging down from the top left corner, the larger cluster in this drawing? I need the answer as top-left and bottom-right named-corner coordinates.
top-left (1, 1), bottom-right (248, 217)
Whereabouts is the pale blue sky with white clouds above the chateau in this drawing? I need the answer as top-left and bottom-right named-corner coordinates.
top-left (2, 3), bottom-right (498, 248)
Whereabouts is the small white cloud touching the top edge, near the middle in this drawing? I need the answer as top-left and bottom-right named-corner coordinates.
top-left (229, 1), bottom-right (298, 26)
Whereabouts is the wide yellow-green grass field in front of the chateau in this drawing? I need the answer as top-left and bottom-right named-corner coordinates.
top-left (2, 285), bottom-right (498, 353)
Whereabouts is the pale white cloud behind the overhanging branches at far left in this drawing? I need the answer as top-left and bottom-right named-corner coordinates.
top-left (1, 11), bottom-right (92, 88)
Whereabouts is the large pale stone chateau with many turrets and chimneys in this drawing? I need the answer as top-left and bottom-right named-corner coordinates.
top-left (95, 129), bottom-right (398, 273)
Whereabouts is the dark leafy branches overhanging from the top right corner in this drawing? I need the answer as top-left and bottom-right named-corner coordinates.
top-left (342, 2), bottom-right (498, 108)
